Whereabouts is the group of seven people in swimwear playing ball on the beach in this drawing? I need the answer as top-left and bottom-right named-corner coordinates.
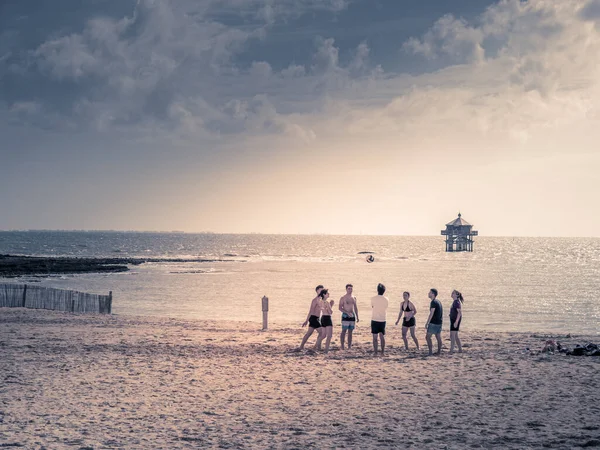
top-left (300, 283), bottom-right (464, 355)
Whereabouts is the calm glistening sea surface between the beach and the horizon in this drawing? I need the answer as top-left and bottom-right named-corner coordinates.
top-left (0, 231), bottom-right (600, 334)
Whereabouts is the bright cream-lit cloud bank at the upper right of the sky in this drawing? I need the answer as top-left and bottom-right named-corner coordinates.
top-left (317, 0), bottom-right (600, 147)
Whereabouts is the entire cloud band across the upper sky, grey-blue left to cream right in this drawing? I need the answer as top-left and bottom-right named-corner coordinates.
top-left (10, 0), bottom-right (600, 153)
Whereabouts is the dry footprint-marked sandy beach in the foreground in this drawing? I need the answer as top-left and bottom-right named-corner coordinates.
top-left (0, 308), bottom-right (600, 449)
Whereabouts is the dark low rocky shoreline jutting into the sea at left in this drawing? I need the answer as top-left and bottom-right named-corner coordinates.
top-left (0, 255), bottom-right (239, 278)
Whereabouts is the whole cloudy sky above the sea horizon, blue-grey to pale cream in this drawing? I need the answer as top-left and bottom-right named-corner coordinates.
top-left (0, 0), bottom-right (600, 237)
